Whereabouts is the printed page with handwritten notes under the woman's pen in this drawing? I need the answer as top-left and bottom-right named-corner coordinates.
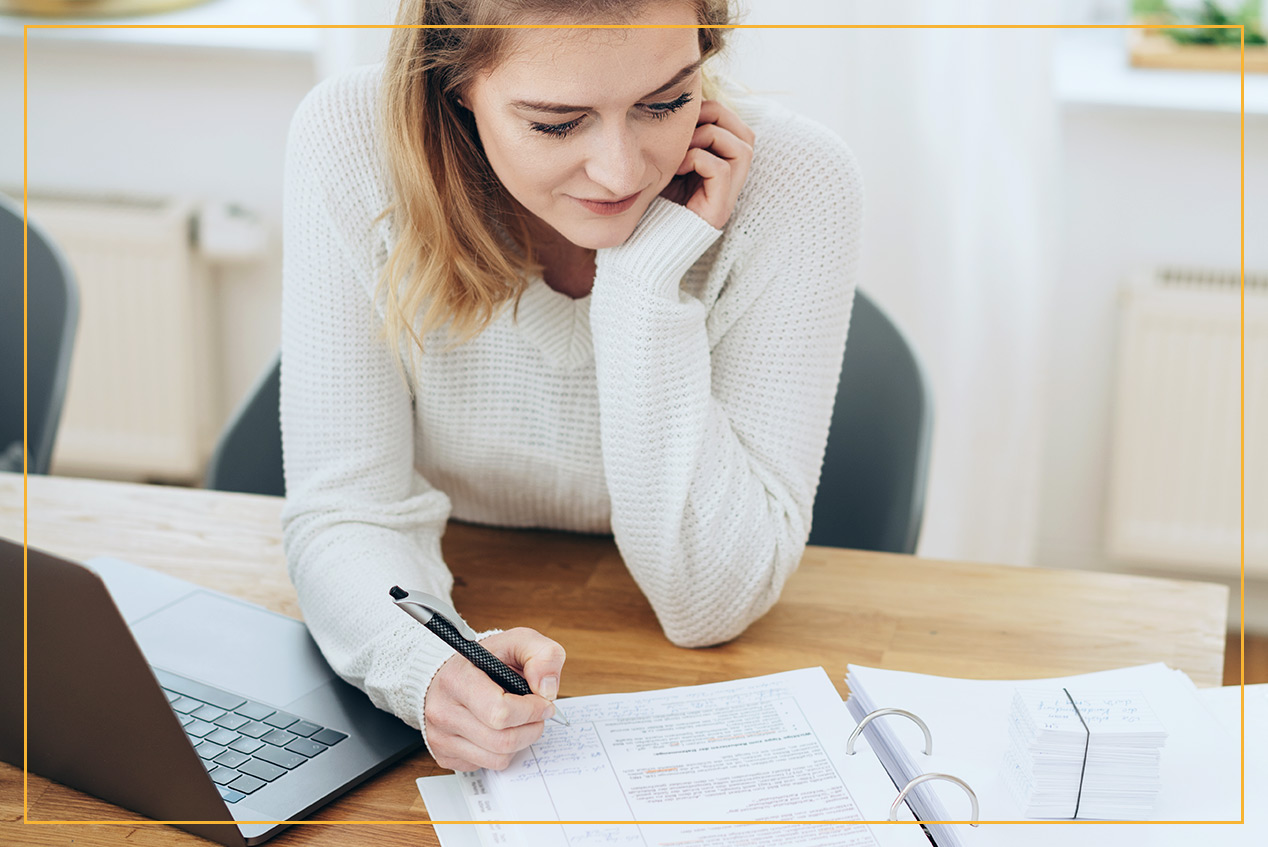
top-left (418, 668), bottom-right (928, 847)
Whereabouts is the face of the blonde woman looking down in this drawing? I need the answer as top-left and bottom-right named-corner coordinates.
top-left (463, 3), bottom-right (700, 250)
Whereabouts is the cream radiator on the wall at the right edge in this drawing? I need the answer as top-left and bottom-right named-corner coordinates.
top-left (1107, 268), bottom-right (1268, 577)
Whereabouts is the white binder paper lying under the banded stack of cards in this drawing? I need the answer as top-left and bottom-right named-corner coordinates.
top-left (848, 663), bottom-right (1247, 847)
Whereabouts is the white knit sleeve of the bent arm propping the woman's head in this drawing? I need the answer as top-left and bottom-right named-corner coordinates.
top-left (591, 119), bottom-right (861, 647)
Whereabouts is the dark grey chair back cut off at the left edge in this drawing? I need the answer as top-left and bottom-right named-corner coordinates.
top-left (0, 194), bottom-right (79, 473)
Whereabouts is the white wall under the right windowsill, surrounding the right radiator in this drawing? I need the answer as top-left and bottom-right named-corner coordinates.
top-left (1036, 100), bottom-right (1268, 631)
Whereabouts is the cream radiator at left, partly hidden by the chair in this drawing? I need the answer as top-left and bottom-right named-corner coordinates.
top-left (29, 197), bottom-right (218, 482)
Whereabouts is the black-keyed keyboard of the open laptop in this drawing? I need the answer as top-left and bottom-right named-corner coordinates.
top-left (153, 668), bottom-right (347, 803)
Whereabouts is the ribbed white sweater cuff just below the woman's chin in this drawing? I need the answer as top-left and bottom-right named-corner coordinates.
top-left (595, 197), bottom-right (721, 299)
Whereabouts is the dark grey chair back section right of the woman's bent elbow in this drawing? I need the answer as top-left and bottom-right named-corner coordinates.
top-left (809, 292), bottom-right (933, 553)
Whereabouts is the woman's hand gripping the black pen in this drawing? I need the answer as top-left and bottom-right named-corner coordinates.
top-left (422, 626), bottom-right (564, 771)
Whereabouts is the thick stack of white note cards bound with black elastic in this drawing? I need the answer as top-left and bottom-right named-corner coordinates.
top-left (1004, 689), bottom-right (1167, 820)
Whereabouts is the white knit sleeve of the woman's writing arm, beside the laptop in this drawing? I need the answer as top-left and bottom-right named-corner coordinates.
top-left (281, 76), bottom-right (453, 745)
